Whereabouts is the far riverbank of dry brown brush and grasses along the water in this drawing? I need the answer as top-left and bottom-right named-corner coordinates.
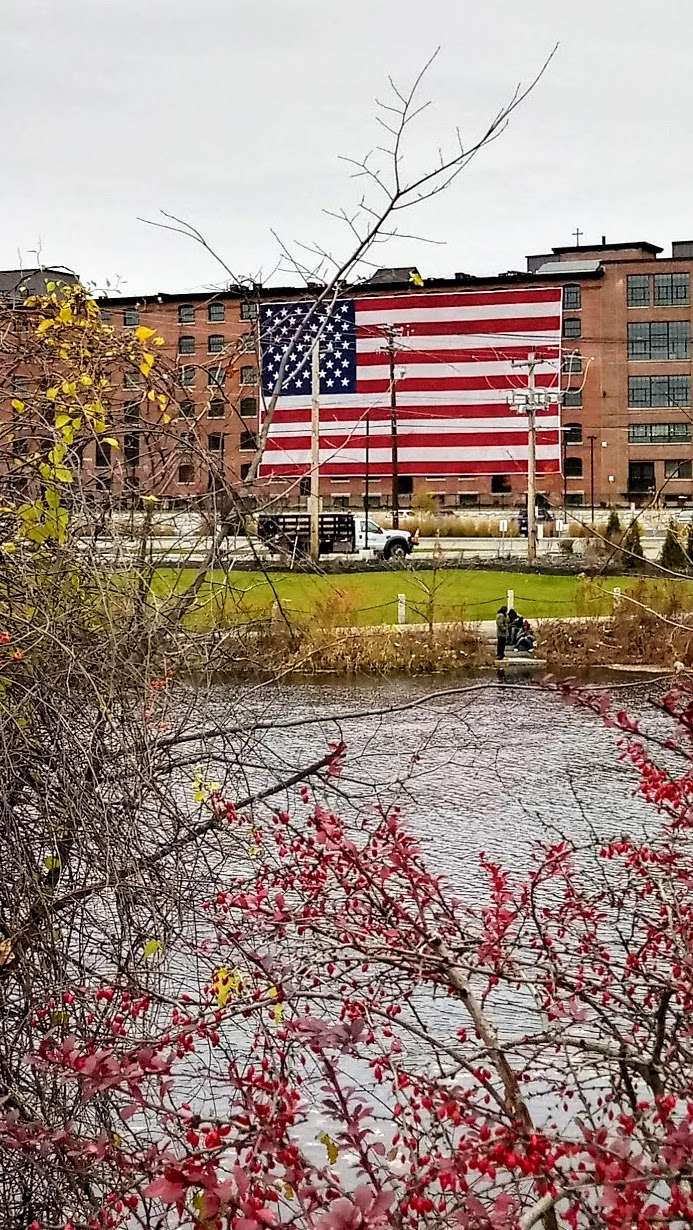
top-left (160, 578), bottom-right (693, 679)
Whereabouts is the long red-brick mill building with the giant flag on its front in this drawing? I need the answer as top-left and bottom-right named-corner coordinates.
top-left (96, 242), bottom-right (693, 509)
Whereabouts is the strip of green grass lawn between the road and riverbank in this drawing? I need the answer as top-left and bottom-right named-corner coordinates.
top-left (148, 568), bottom-right (664, 630)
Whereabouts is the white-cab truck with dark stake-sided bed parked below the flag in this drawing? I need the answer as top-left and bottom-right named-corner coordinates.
top-left (257, 512), bottom-right (419, 560)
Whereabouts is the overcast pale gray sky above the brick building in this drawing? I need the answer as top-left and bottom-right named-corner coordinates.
top-left (0, 0), bottom-right (693, 294)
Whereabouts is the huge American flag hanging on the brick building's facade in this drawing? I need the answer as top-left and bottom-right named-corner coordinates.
top-left (260, 287), bottom-right (561, 477)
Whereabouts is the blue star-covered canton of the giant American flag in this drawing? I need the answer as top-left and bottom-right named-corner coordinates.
top-left (260, 301), bottom-right (356, 397)
